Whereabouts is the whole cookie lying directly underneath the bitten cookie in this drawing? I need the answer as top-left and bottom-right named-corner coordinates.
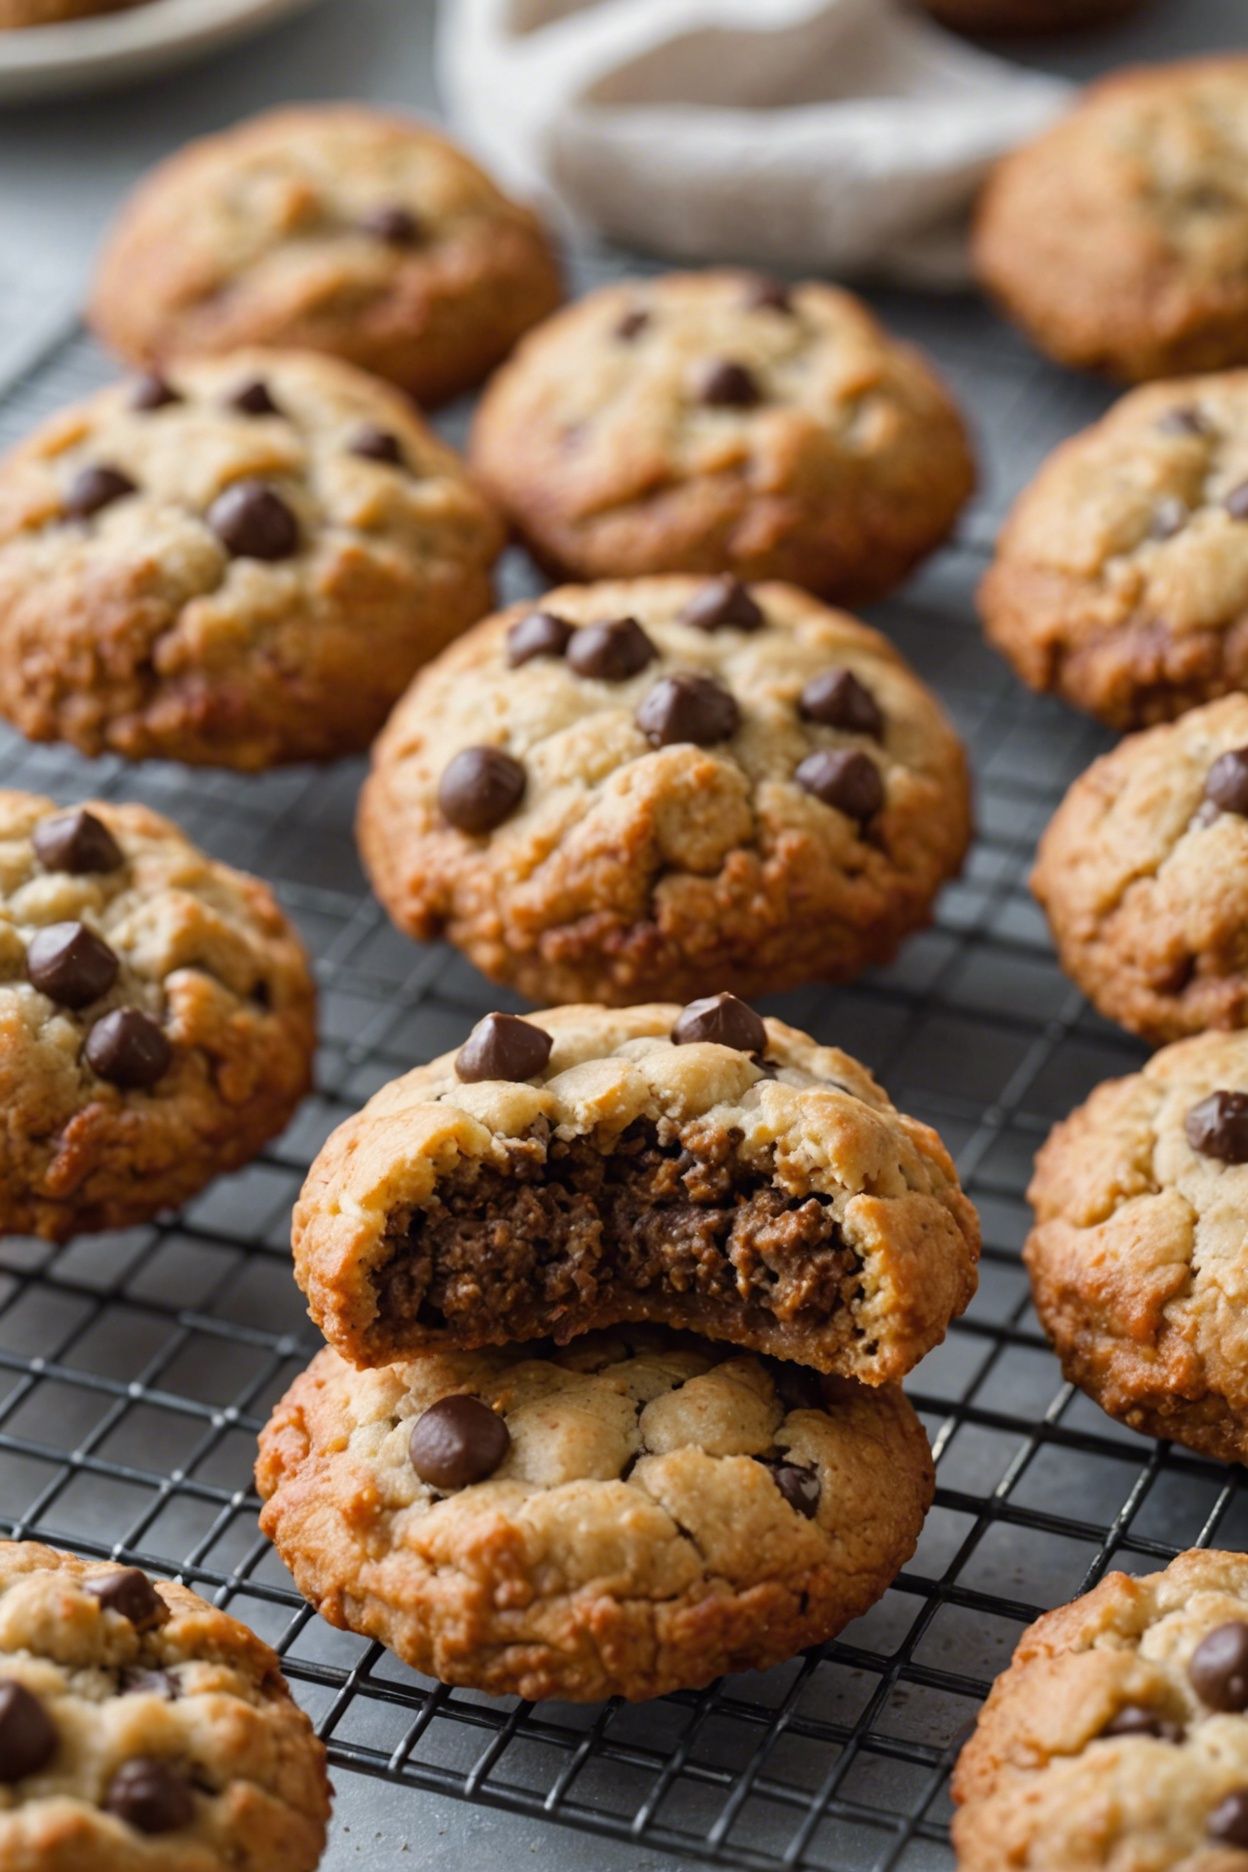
top-left (256, 1329), bottom-right (932, 1702)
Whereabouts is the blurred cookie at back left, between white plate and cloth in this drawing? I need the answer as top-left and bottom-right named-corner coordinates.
top-left (92, 105), bottom-right (561, 402)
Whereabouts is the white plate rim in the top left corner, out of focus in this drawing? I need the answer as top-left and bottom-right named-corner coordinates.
top-left (0, 0), bottom-right (327, 103)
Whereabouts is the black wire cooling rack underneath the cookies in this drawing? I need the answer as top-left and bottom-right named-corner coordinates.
top-left (0, 260), bottom-right (1248, 1872)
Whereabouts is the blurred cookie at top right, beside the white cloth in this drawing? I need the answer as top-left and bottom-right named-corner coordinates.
top-left (975, 56), bottom-right (1248, 382)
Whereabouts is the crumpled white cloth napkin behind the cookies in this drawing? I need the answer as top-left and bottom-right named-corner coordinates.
top-left (440, 0), bottom-right (1067, 285)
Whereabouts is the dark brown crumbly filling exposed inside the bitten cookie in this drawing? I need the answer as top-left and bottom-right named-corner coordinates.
top-left (366, 1121), bottom-right (861, 1357)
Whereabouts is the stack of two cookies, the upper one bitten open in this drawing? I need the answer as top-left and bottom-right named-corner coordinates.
top-left (256, 996), bottom-right (979, 1700)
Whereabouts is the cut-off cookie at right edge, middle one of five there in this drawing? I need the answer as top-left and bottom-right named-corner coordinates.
top-left (1031, 695), bottom-right (1248, 1043)
